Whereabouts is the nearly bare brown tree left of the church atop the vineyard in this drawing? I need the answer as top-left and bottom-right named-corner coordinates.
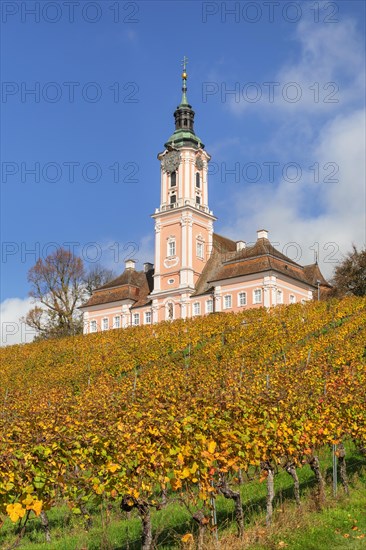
top-left (23, 248), bottom-right (85, 339)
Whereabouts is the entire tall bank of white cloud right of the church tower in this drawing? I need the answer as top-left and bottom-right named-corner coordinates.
top-left (214, 14), bottom-right (366, 277)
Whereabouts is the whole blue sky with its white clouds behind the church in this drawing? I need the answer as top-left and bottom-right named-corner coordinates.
top-left (1, 0), bottom-right (365, 344)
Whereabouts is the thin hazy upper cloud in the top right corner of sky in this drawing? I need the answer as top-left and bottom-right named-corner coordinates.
top-left (227, 17), bottom-right (365, 116)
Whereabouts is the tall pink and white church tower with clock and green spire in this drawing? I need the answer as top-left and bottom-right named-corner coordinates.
top-left (151, 58), bottom-right (216, 321)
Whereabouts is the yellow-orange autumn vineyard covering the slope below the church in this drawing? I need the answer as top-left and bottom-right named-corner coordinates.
top-left (0, 298), bottom-right (366, 550)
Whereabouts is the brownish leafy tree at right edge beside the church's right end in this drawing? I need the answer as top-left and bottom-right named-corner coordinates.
top-left (331, 245), bottom-right (366, 296)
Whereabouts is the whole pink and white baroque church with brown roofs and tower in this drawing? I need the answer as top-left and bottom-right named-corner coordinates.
top-left (80, 65), bottom-right (330, 333)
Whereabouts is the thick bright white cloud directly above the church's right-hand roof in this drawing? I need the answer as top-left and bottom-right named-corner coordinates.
top-left (222, 110), bottom-right (366, 276)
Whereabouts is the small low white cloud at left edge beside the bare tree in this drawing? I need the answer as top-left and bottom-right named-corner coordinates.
top-left (0, 298), bottom-right (35, 346)
